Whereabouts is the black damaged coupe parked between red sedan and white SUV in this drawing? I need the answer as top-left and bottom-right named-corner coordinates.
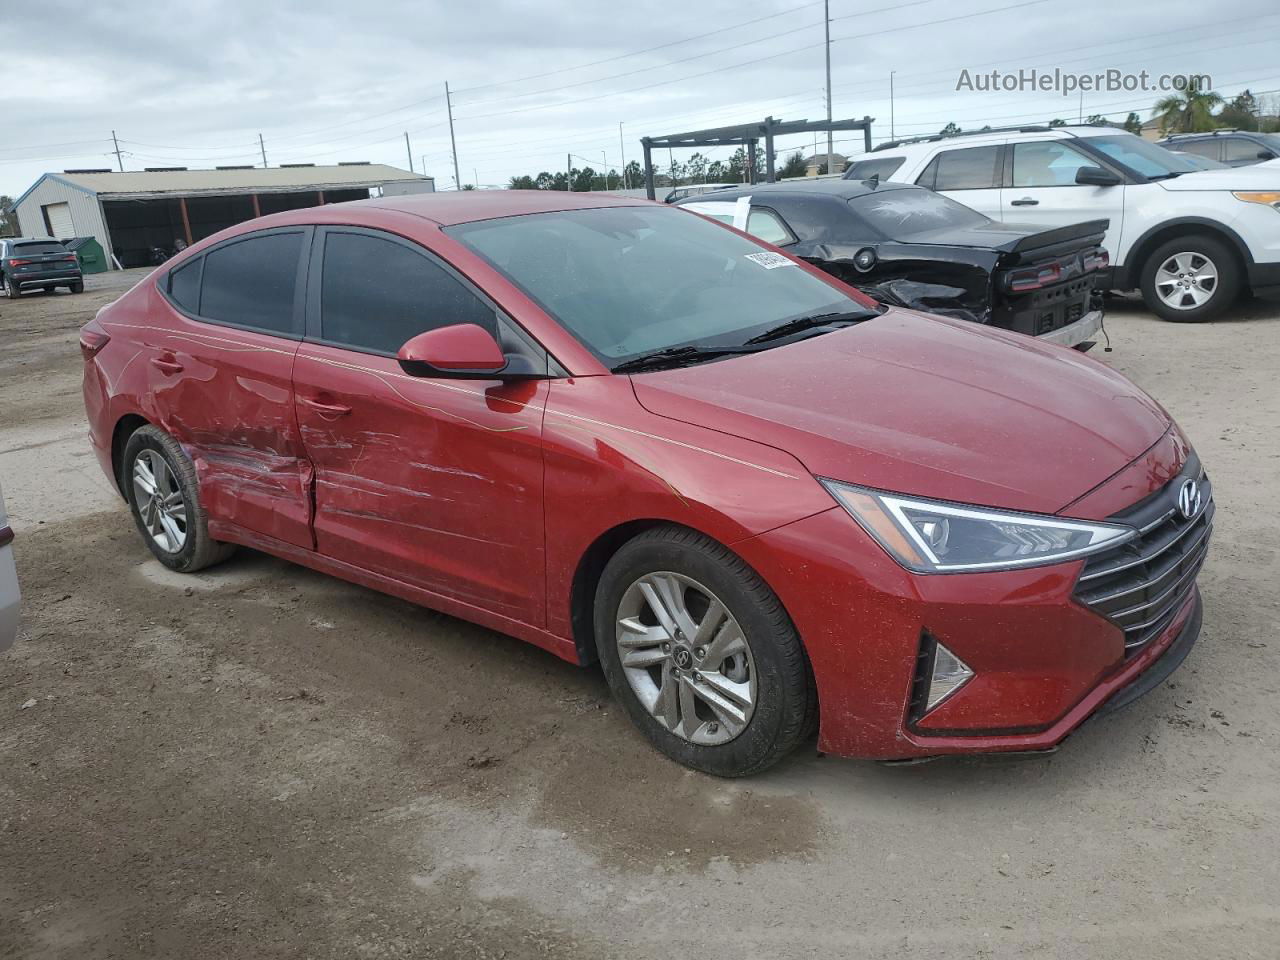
top-left (680, 179), bottom-right (1107, 349)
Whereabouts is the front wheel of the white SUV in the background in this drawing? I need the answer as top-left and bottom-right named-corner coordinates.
top-left (1139, 234), bottom-right (1243, 324)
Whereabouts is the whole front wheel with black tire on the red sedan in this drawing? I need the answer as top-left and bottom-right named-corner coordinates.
top-left (595, 527), bottom-right (817, 777)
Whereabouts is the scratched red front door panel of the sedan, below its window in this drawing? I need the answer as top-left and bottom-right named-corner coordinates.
top-left (294, 343), bottom-right (547, 626)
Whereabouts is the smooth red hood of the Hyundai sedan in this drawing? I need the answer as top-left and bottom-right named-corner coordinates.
top-left (632, 310), bottom-right (1170, 513)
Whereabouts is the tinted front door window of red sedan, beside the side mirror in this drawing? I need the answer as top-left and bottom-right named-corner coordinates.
top-left (320, 230), bottom-right (498, 356)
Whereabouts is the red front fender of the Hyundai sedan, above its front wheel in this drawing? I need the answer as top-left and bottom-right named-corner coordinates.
top-left (544, 376), bottom-right (832, 636)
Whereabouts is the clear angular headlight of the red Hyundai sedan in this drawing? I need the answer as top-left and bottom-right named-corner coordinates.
top-left (822, 480), bottom-right (1137, 573)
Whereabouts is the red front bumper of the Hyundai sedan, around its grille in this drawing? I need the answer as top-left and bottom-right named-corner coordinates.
top-left (735, 448), bottom-right (1201, 759)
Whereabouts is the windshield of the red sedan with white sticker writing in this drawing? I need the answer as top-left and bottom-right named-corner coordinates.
top-left (447, 206), bottom-right (870, 367)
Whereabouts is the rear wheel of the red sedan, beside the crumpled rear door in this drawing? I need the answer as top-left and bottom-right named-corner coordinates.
top-left (122, 424), bottom-right (236, 573)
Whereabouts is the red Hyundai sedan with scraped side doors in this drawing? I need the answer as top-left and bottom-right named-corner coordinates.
top-left (81, 191), bottom-right (1213, 776)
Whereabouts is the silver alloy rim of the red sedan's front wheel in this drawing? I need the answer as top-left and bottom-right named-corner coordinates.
top-left (616, 572), bottom-right (756, 746)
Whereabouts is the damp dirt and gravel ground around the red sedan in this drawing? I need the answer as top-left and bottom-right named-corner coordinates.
top-left (0, 273), bottom-right (1280, 960)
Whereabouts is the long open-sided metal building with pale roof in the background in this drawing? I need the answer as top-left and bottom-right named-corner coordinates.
top-left (14, 164), bottom-right (435, 266)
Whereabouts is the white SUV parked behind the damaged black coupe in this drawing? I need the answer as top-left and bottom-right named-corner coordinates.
top-left (845, 127), bottom-right (1280, 323)
